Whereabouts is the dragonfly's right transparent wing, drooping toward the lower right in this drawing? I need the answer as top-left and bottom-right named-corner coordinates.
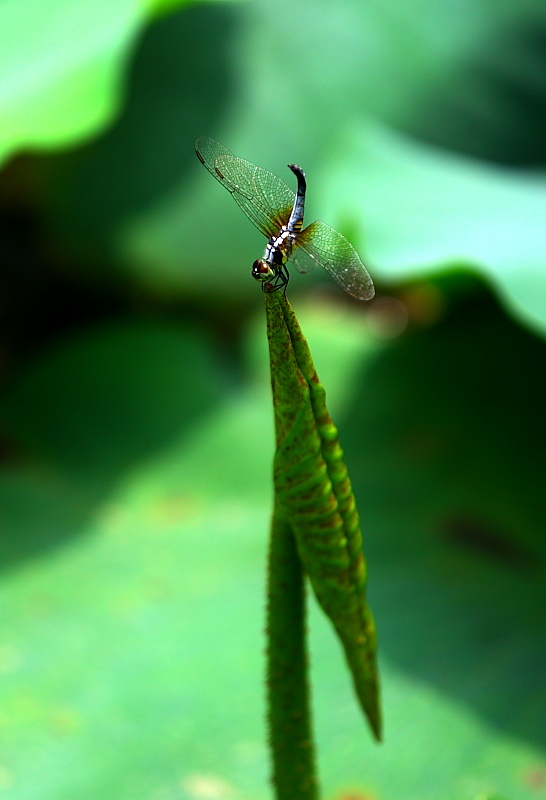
top-left (292, 221), bottom-right (375, 300)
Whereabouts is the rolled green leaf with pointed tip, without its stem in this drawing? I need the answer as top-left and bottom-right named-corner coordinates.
top-left (265, 293), bottom-right (381, 739)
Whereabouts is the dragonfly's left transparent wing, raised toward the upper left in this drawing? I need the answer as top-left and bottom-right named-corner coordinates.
top-left (195, 136), bottom-right (296, 238)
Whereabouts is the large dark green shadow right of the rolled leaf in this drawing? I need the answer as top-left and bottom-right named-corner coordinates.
top-left (338, 280), bottom-right (546, 746)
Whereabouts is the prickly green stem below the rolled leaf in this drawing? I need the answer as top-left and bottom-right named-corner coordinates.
top-left (267, 507), bottom-right (318, 800)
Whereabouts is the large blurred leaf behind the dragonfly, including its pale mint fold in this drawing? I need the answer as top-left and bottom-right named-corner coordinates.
top-left (42, 0), bottom-right (546, 330)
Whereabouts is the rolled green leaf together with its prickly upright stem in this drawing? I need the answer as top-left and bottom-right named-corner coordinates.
top-left (265, 293), bottom-right (381, 800)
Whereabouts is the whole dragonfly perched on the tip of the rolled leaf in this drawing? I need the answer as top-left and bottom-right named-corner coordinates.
top-left (195, 136), bottom-right (375, 300)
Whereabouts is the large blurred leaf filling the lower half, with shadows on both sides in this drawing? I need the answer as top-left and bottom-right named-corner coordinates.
top-left (0, 300), bottom-right (546, 800)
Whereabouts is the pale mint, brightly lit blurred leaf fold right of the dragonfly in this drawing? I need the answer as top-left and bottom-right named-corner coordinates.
top-left (319, 124), bottom-right (546, 333)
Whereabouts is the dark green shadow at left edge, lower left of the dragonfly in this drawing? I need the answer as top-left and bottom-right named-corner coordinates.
top-left (0, 320), bottom-right (227, 568)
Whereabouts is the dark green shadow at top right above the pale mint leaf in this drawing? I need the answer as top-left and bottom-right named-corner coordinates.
top-left (403, 22), bottom-right (546, 166)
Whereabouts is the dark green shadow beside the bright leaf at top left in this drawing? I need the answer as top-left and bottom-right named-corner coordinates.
top-left (48, 4), bottom-right (238, 268)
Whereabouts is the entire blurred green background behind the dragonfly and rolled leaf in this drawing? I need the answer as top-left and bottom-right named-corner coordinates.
top-left (0, 0), bottom-right (546, 800)
